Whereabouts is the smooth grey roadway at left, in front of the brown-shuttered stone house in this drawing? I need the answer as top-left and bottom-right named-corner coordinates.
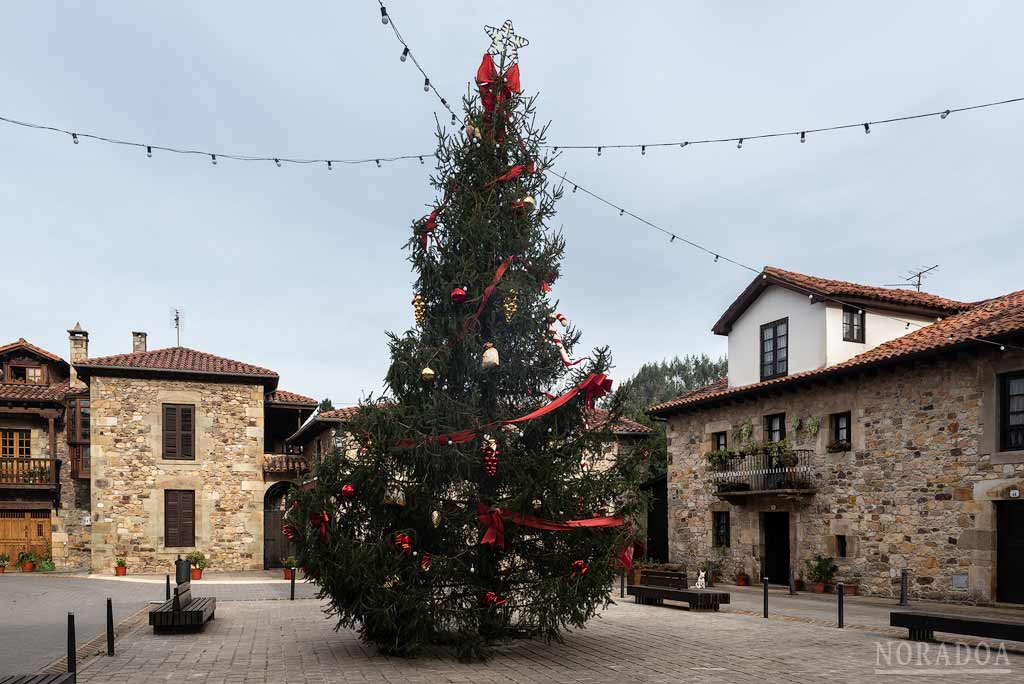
top-left (0, 572), bottom-right (316, 678)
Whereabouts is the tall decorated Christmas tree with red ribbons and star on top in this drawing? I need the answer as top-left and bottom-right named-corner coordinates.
top-left (285, 22), bottom-right (642, 658)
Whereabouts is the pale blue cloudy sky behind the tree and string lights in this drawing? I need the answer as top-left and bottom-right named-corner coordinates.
top-left (0, 0), bottom-right (1024, 405)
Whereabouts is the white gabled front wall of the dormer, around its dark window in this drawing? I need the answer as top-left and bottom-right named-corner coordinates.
top-left (729, 285), bottom-right (827, 387)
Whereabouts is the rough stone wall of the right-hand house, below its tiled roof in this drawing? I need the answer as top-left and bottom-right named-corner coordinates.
top-left (668, 351), bottom-right (1024, 601)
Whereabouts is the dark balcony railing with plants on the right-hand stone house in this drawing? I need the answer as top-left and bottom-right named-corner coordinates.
top-left (710, 450), bottom-right (814, 497)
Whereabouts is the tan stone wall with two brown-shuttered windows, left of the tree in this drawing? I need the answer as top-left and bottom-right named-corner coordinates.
top-left (90, 375), bottom-right (264, 572)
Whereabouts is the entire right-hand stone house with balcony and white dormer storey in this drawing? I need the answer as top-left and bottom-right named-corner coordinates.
top-left (648, 267), bottom-right (1024, 604)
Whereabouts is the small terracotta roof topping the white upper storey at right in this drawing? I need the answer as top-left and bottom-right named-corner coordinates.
top-left (712, 266), bottom-right (973, 335)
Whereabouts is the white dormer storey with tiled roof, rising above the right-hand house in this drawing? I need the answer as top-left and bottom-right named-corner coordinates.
top-left (713, 266), bottom-right (968, 387)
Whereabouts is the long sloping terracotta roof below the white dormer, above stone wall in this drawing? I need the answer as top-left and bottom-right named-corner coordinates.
top-left (647, 290), bottom-right (1024, 416)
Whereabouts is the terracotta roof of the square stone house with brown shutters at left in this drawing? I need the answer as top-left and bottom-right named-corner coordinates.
top-left (75, 347), bottom-right (278, 386)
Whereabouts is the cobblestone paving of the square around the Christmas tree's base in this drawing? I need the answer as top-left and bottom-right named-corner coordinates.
top-left (79, 600), bottom-right (1024, 684)
